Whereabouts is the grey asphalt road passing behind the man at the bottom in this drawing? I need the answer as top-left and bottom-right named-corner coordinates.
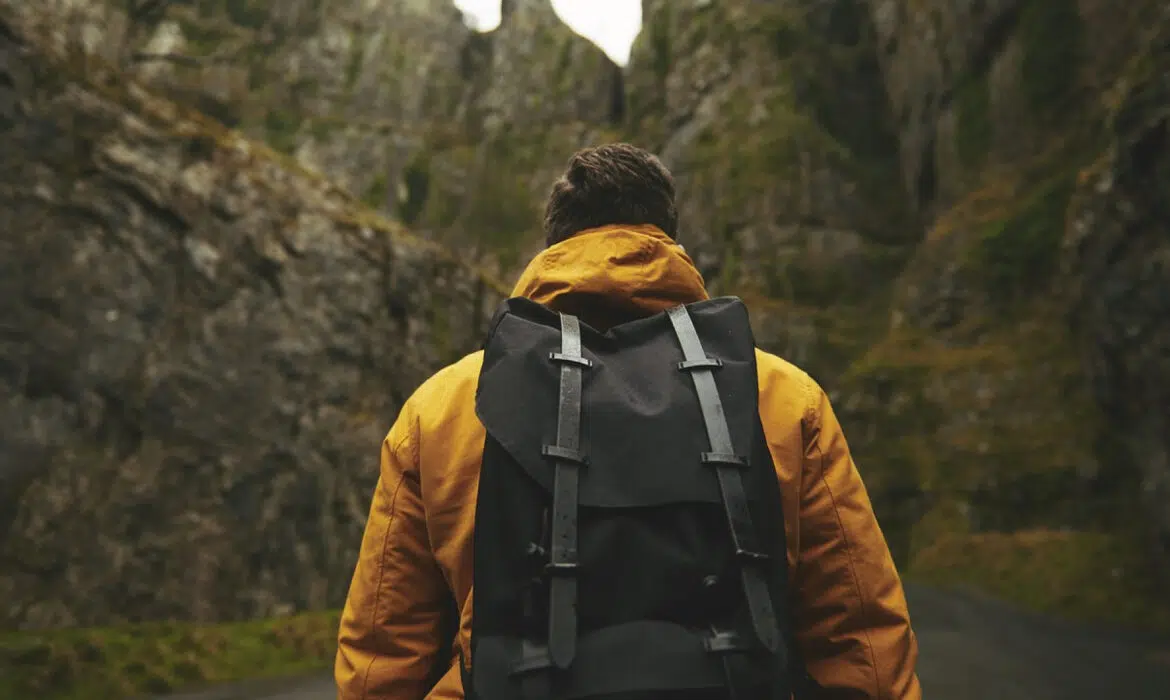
top-left (160, 585), bottom-right (1170, 700)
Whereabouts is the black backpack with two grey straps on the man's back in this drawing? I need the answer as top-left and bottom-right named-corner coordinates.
top-left (460, 297), bottom-right (808, 700)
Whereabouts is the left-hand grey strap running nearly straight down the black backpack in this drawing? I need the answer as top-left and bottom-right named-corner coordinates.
top-left (542, 314), bottom-right (593, 670)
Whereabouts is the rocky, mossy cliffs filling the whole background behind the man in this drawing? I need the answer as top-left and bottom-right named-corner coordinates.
top-left (0, 0), bottom-right (1170, 626)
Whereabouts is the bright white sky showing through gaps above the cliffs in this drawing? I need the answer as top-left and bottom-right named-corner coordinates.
top-left (455, 0), bottom-right (642, 66)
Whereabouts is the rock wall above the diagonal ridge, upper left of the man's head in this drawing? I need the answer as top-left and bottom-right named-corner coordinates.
top-left (7, 0), bottom-right (622, 261)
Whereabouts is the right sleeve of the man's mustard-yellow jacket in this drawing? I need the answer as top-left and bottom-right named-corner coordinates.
top-left (793, 386), bottom-right (922, 700)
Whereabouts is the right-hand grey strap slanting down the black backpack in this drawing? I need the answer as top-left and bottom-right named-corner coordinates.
top-left (669, 307), bottom-right (780, 653)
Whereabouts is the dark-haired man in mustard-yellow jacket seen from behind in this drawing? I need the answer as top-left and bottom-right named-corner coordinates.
top-left (336, 144), bottom-right (921, 700)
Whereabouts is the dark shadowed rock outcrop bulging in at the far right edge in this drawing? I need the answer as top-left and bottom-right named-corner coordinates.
top-left (1064, 23), bottom-right (1170, 571)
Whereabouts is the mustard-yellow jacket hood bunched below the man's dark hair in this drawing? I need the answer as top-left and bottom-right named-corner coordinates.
top-left (512, 226), bottom-right (708, 329)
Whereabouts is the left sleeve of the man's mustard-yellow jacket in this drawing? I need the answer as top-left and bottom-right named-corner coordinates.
top-left (333, 402), bottom-right (447, 700)
